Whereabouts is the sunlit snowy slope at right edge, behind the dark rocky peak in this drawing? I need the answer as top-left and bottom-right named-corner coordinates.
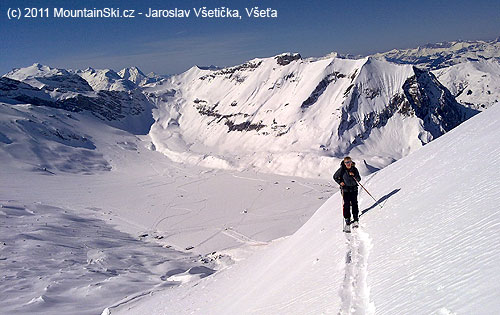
top-left (434, 61), bottom-right (500, 110)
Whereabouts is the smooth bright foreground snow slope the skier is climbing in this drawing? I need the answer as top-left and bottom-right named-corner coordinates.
top-left (119, 106), bottom-right (500, 314)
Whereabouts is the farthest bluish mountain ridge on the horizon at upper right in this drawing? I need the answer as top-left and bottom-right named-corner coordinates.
top-left (373, 37), bottom-right (500, 70)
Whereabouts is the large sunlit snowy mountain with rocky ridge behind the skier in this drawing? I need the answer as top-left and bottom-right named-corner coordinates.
top-left (146, 54), bottom-right (474, 177)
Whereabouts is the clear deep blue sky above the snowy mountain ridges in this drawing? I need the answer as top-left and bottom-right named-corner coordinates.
top-left (0, 0), bottom-right (500, 74)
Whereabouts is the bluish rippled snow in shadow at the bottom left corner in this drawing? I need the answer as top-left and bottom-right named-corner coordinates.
top-left (0, 200), bottom-right (200, 314)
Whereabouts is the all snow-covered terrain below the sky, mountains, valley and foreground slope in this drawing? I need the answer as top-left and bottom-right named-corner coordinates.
top-left (0, 42), bottom-right (500, 314)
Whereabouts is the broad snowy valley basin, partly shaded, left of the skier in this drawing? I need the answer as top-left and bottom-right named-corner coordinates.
top-left (0, 102), bottom-right (332, 314)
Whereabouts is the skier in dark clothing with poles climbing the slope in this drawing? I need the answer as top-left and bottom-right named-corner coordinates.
top-left (333, 156), bottom-right (361, 232)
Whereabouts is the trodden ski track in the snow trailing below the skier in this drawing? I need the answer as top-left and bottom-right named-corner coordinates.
top-left (339, 228), bottom-right (375, 315)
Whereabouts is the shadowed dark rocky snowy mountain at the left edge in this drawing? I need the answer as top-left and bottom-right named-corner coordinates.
top-left (0, 64), bottom-right (153, 139)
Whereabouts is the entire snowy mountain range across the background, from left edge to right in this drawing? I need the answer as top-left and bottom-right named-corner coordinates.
top-left (0, 40), bottom-right (500, 177)
